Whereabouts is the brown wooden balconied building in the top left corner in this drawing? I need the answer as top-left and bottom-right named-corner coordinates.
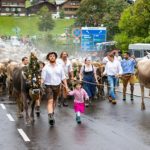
top-left (0, 0), bottom-right (26, 16)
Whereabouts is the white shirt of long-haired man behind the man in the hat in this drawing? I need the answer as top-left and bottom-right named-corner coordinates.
top-left (57, 59), bottom-right (73, 79)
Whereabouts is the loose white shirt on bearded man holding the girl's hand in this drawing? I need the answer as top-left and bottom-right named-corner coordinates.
top-left (42, 63), bottom-right (66, 85)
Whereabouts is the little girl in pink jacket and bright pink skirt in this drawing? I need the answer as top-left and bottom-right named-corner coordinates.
top-left (69, 82), bottom-right (89, 124)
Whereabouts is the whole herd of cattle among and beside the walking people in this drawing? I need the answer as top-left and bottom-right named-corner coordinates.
top-left (0, 54), bottom-right (150, 124)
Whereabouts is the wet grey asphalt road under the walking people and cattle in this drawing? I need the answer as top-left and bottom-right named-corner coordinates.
top-left (0, 93), bottom-right (150, 150)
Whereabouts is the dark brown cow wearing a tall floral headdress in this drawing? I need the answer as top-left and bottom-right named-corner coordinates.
top-left (12, 54), bottom-right (41, 125)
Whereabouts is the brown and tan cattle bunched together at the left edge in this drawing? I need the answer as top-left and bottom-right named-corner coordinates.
top-left (0, 56), bottom-right (41, 124)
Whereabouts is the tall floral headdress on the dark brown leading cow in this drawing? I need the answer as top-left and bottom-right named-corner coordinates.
top-left (28, 52), bottom-right (41, 89)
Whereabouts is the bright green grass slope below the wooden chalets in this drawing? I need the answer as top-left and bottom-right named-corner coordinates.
top-left (0, 16), bottom-right (74, 35)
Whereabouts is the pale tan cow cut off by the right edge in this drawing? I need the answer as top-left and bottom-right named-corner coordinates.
top-left (136, 59), bottom-right (150, 110)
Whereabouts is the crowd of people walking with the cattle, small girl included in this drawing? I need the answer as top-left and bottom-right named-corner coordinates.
top-left (22, 51), bottom-right (136, 126)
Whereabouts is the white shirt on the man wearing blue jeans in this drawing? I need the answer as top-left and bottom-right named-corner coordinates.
top-left (104, 60), bottom-right (123, 76)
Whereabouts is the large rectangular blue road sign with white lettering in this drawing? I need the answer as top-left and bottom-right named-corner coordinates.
top-left (81, 27), bottom-right (107, 51)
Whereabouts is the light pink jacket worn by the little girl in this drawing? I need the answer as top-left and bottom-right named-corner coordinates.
top-left (69, 88), bottom-right (89, 103)
